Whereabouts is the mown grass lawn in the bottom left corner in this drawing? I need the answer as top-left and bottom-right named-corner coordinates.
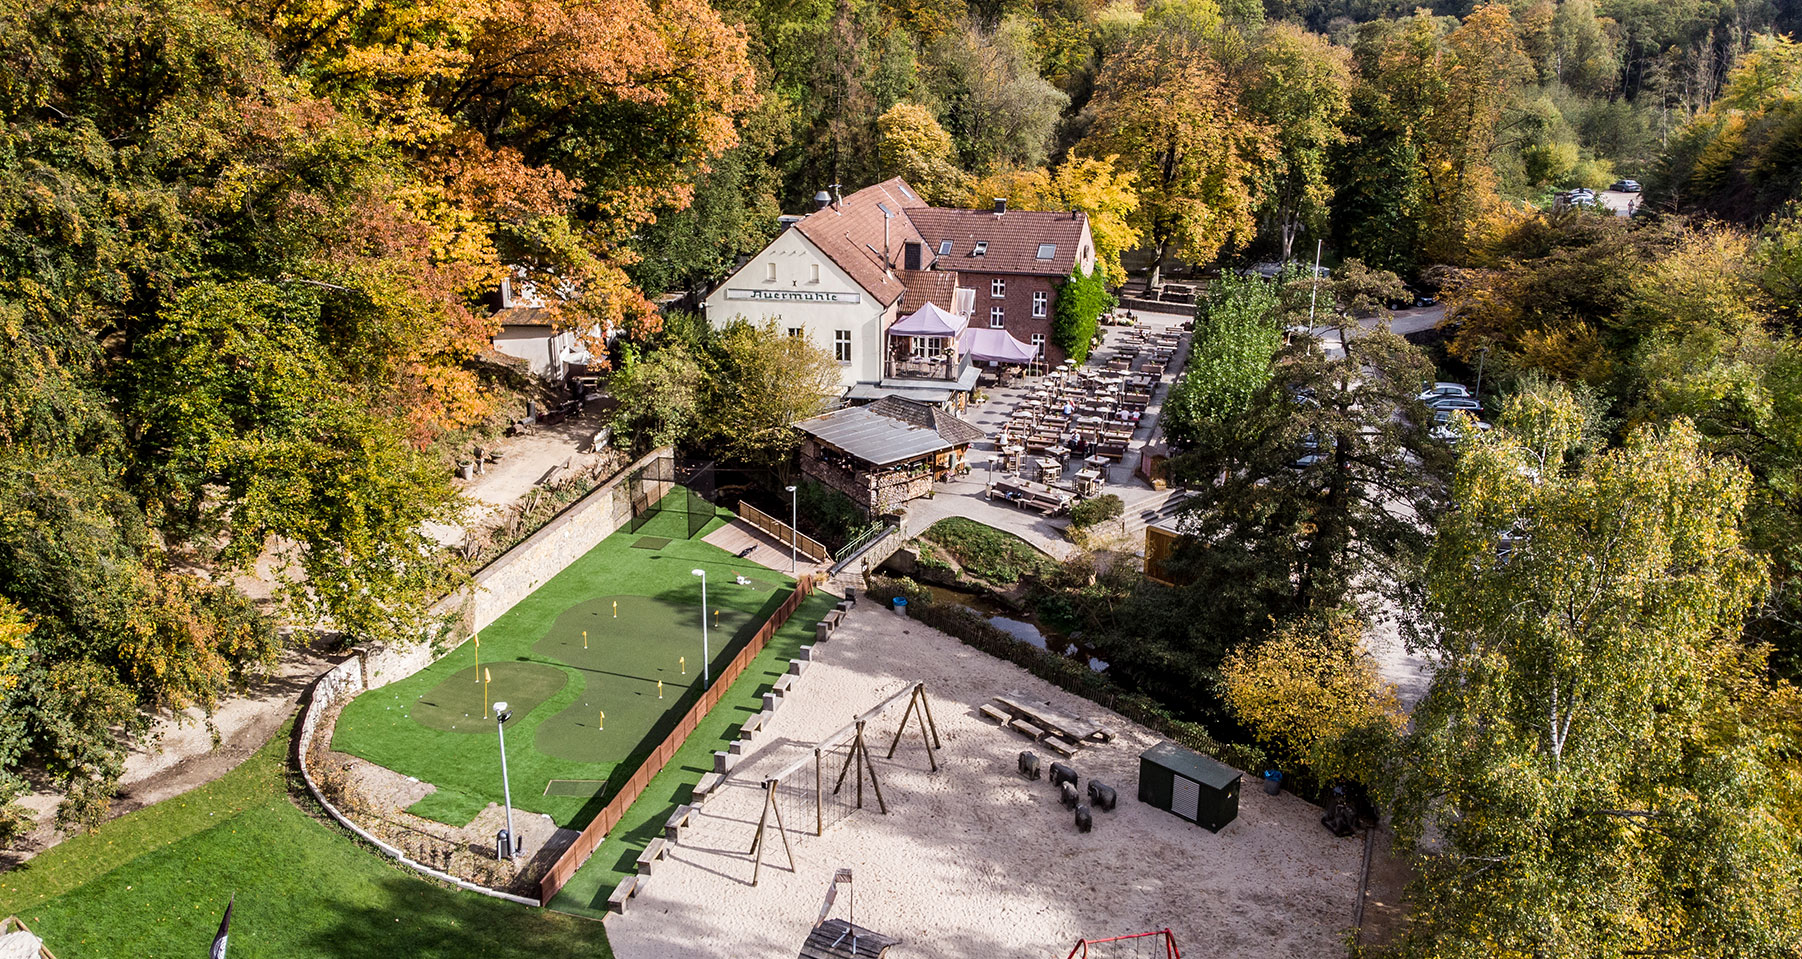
top-left (0, 726), bottom-right (613, 959)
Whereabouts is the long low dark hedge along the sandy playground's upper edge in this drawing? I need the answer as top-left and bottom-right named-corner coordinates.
top-left (863, 577), bottom-right (1270, 773)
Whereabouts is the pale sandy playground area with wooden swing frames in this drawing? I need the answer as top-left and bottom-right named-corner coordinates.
top-left (607, 602), bottom-right (1362, 959)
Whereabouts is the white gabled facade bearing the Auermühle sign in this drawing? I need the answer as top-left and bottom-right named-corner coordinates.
top-left (706, 227), bottom-right (899, 386)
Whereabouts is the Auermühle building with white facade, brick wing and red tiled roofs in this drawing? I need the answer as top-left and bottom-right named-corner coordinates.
top-left (706, 177), bottom-right (1096, 406)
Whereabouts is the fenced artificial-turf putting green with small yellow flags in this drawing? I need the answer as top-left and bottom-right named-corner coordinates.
top-left (332, 490), bottom-right (793, 827)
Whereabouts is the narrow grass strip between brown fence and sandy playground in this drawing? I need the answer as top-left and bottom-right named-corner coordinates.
top-left (550, 593), bottom-right (838, 918)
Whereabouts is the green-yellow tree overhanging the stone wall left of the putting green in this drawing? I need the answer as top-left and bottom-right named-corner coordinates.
top-left (128, 283), bottom-right (452, 640)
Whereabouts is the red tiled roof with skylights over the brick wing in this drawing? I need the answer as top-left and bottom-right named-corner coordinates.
top-left (906, 206), bottom-right (1088, 276)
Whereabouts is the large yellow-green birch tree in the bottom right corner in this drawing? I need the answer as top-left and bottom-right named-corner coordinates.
top-left (1395, 400), bottom-right (1802, 957)
